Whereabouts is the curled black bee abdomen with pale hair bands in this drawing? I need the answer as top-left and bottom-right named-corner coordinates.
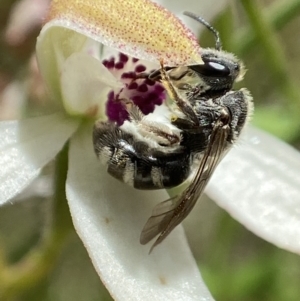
top-left (93, 122), bottom-right (191, 189)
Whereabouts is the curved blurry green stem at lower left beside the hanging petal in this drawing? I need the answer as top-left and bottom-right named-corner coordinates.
top-left (0, 145), bottom-right (73, 300)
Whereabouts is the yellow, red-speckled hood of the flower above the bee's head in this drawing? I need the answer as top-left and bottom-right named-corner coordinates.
top-left (47, 0), bottom-right (202, 65)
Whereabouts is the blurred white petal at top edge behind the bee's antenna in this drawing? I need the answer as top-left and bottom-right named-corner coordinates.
top-left (153, 0), bottom-right (228, 34)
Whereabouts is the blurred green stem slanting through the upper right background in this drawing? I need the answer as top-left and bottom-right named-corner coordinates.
top-left (241, 0), bottom-right (300, 110)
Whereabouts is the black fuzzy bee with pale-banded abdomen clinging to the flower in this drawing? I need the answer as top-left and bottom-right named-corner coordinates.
top-left (93, 12), bottom-right (252, 252)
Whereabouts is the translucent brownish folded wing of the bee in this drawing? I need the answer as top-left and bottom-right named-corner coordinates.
top-left (140, 121), bottom-right (230, 252)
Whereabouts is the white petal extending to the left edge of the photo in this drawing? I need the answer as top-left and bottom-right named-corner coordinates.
top-left (0, 114), bottom-right (77, 205)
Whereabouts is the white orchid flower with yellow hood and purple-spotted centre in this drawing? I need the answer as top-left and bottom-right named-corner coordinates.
top-left (0, 0), bottom-right (300, 300)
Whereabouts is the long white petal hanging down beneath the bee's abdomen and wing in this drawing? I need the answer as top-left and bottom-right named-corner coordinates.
top-left (66, 126), bottom-right (213, 301)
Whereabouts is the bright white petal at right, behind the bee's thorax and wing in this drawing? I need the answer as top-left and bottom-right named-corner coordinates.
top-left (207, 128), bottom-right (300, 253)
